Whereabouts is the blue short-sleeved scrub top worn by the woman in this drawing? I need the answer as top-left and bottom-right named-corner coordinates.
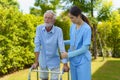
top-left (68, 22), bottom-right (91, 66)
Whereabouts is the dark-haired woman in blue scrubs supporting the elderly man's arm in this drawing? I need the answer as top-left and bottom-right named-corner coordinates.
top-left (61, 6), bottom-right (91, 80)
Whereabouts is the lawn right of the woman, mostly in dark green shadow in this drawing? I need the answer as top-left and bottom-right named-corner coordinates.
top-left (92, 58), bottom-right (120, 80)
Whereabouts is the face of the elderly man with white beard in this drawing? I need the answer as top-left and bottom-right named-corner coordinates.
top-left (44, 13), bottom-right (54, 27)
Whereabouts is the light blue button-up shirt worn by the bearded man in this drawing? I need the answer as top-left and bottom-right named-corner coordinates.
top-left (34, 25), bottom-right (67, 69)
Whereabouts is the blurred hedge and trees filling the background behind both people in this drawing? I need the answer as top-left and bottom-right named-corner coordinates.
top-left (0, 0), bottom-right (120, 80)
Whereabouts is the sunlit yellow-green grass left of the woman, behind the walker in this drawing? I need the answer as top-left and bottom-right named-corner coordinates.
top-left (0, 64), bottom-right (68, 80)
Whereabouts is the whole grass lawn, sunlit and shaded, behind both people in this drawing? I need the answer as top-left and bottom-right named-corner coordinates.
top-left (0, 58), bottom-right (120, 80)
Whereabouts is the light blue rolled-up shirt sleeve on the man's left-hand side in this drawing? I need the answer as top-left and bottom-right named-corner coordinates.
top-left (34, 27), bottom-right (41, 52)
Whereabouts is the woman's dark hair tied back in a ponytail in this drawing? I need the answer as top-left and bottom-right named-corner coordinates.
top-left (69, 6), bottom-right (90, 25)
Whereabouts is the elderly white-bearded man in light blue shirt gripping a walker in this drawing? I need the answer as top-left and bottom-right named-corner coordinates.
top-left (32, 10), bottom-right (69, 80)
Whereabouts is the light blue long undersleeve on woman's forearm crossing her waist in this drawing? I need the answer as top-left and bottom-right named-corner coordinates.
top-left (68, 45), bottom-right (89, 58)
